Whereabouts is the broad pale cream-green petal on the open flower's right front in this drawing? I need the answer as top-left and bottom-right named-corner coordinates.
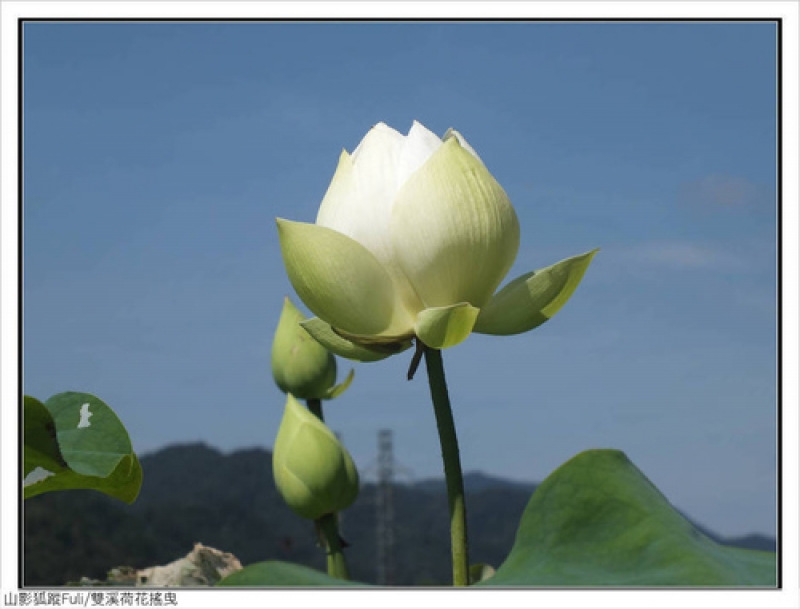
top-left (392, 138), bottom-right (519, 308)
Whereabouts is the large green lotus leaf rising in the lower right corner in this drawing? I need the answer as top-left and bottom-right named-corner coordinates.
top-left (478, 450), bottom-right (776, 587)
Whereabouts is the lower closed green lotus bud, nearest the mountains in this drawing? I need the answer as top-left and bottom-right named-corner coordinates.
top-left (272, 394), bottom-right (358, 520)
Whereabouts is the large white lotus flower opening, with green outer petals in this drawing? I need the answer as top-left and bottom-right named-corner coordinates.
top-left (278, 122), bottom-right (594, 361)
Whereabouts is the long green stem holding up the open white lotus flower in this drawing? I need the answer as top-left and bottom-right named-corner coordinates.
top-left (425, 347), bottom-right (469, 586)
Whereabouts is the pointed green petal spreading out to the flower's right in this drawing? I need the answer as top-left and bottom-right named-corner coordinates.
top-left (473, 249), bottom-right (598, 335)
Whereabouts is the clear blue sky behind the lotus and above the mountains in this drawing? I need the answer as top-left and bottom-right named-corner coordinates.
top-left (24, 22), bottom-right (776, 535)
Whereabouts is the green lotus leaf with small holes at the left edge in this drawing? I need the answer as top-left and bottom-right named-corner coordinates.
top-left (23, 392), bottom-right (142, 503)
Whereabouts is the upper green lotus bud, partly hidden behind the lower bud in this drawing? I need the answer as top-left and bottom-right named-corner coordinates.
top-left (272, 297), bottom-right (353, 400)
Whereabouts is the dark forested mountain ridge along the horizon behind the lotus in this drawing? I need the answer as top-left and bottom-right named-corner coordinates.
top-left (23, 444), bottom-right (775, 586)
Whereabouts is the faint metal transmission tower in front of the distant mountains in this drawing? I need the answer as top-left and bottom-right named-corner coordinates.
top-left (375, 429), bottom-right (394, 586)
